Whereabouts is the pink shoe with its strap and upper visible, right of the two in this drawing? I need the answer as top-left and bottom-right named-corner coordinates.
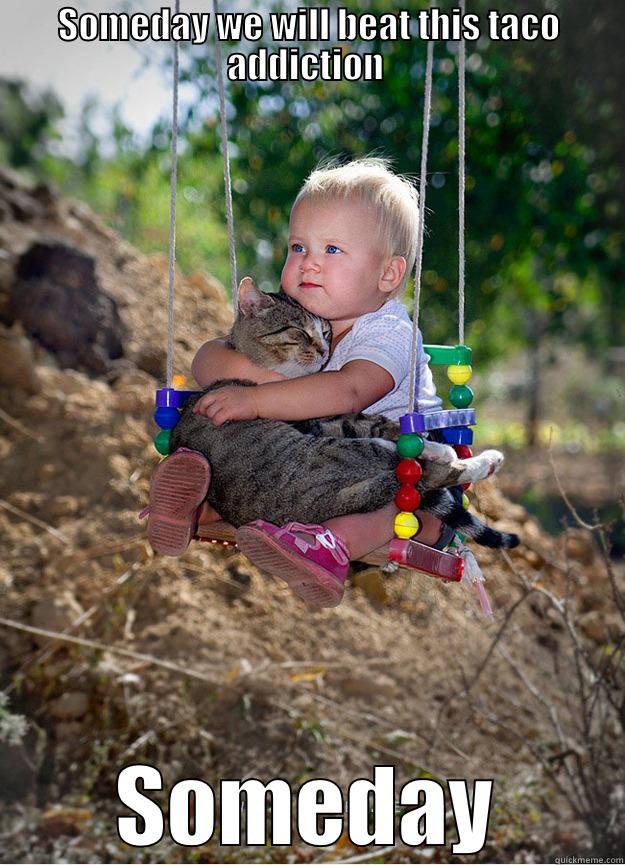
top-left (237, 520), bottom-right (349, 607)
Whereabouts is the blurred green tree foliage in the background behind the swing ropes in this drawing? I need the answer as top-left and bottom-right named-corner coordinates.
top-left (0, 0), bottom-right (625, 362)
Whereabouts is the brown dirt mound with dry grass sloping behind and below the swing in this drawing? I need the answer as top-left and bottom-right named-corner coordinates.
top-left (0, 173), bottom-right (622, 861)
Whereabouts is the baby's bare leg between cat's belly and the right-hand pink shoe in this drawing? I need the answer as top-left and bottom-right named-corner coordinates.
top-left (324, 502), bottom-right (442, 559)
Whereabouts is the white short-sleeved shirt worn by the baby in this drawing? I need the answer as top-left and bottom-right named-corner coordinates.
top-left (323, 300), bottom-right (442, 420)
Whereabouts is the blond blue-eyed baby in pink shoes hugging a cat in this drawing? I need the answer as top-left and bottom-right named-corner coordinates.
top-left (148, 158), bottom-right (444, 606)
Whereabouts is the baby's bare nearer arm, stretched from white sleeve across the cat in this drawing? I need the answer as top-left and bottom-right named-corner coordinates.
top-left (193, 360), bottom-right (394, 425)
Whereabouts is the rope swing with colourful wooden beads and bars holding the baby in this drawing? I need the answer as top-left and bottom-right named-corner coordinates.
top-left (154, 0), bottom-right (476, 582)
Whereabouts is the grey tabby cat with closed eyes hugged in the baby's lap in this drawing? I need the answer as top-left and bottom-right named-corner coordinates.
top-left (171, 278), bottom-right (518, 547)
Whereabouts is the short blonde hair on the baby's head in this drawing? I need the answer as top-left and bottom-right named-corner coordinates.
top-left (293, 156), bottom-right (419, 297)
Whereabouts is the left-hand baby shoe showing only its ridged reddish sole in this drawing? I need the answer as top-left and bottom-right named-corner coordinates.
top-left (148, 448), bottom-right (211, 556)
